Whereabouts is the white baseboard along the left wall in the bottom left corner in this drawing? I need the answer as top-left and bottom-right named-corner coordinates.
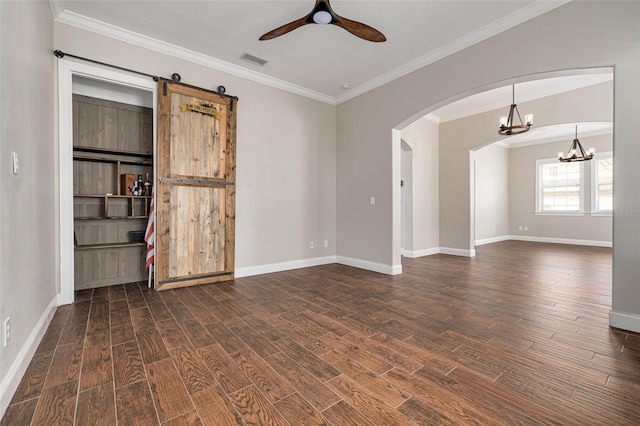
top-left (0, 295), bottom-right (59, 418)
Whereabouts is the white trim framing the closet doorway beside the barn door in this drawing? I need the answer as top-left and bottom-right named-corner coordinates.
top-left (55, 59), bottom-right (157, 305)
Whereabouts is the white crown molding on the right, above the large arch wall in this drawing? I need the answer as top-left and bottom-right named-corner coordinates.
top-left (336, 0), bottom-right (571, 104)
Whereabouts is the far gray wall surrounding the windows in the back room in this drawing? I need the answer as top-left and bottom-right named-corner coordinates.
top-left (509, 134), bottom-right (617, 243)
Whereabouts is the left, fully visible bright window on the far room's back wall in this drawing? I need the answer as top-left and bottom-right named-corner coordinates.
top-left (536, 158), bottom-right (584, 214)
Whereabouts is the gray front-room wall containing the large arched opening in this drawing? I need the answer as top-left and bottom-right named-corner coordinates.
top-left (337, 1), bottom-right (640, 322)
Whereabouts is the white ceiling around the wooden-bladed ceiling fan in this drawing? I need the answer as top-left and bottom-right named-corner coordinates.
top-left (50, 0), bottom-right (567, 103)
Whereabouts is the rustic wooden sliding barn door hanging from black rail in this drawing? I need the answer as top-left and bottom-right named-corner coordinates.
top-left (155, 80), bottom-right (236, 290)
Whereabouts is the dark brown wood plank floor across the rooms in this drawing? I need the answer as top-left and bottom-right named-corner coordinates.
top-left (2, 242), bottom-right (640, 426)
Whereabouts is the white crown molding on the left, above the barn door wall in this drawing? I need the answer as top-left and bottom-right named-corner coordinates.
top-left (49, 8), bottom-right (336, 105)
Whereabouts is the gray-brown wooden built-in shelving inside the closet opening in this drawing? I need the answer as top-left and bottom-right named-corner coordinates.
top-left (73, 95), bottom-right (153, 290)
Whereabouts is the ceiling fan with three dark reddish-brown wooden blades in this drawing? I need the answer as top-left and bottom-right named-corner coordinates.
top-left (260, 0), bottom-right (387, 43)
